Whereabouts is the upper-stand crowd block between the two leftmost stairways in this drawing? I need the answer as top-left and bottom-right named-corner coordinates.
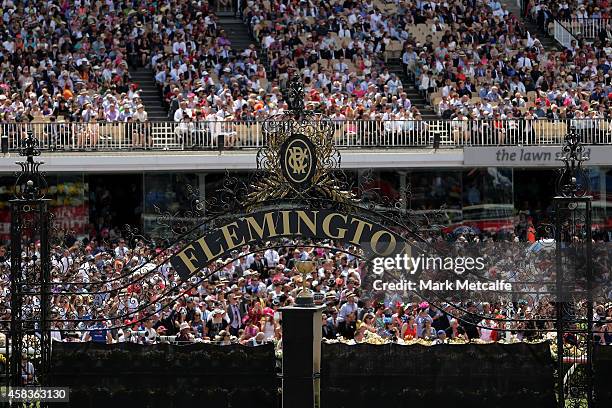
top-left (151, 5), bottom-right (270, 122)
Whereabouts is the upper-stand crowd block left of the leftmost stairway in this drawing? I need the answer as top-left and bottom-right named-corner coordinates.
top-left (0, 0), bottom-right (153, 122)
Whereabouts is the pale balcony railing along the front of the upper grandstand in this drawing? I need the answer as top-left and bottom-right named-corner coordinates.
top-left (0, 119), bottom-right (612, 152)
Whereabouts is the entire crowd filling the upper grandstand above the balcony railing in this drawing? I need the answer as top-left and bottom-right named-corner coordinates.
top-left (0, 0), bottom-right (612, 145)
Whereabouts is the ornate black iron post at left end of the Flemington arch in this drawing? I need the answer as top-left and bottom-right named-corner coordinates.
top-left (7, 131), bottom-right (51, 407)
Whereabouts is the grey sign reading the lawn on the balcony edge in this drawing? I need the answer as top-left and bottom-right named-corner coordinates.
top-left (463, 145), bottom-right (612, 168)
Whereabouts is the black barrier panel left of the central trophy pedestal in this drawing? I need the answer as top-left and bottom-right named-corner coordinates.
top-left (50, 343), bottom-right (280, 408)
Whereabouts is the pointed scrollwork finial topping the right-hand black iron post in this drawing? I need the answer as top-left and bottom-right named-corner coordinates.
top-left (557, 128), bottom-right (589, 197)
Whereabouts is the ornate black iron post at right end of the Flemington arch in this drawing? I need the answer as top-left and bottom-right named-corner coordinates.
top-left (553, 129), bottom-right (593, 408)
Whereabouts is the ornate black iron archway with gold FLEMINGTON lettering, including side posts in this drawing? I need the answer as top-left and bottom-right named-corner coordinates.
top-left (4, 78), bottom-right (592, 406)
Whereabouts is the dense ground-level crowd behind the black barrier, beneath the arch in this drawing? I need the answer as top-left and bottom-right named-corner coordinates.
top-left (0, 226), bottom-right (612, 346)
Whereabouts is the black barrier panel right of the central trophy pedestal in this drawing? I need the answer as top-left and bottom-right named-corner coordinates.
top-left (321, 342), bottom-right (556, 408)
